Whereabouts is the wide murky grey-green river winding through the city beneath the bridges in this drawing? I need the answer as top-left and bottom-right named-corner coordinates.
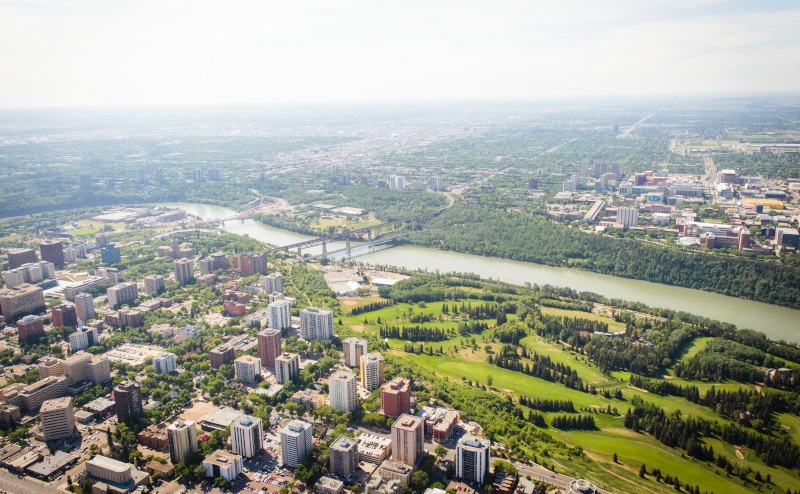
top-left (162, 203), bottom-right (800, 342)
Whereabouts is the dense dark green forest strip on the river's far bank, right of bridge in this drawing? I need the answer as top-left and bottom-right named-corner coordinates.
top-left (407, 205), bottom-right (800, 308)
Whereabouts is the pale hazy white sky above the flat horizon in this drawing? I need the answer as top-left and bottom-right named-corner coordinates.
top-left (0, 0), bottom-right (800, 107)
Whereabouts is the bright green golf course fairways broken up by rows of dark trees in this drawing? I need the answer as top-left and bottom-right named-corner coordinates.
top-left (345, 298), bottom-right (800, 493)
